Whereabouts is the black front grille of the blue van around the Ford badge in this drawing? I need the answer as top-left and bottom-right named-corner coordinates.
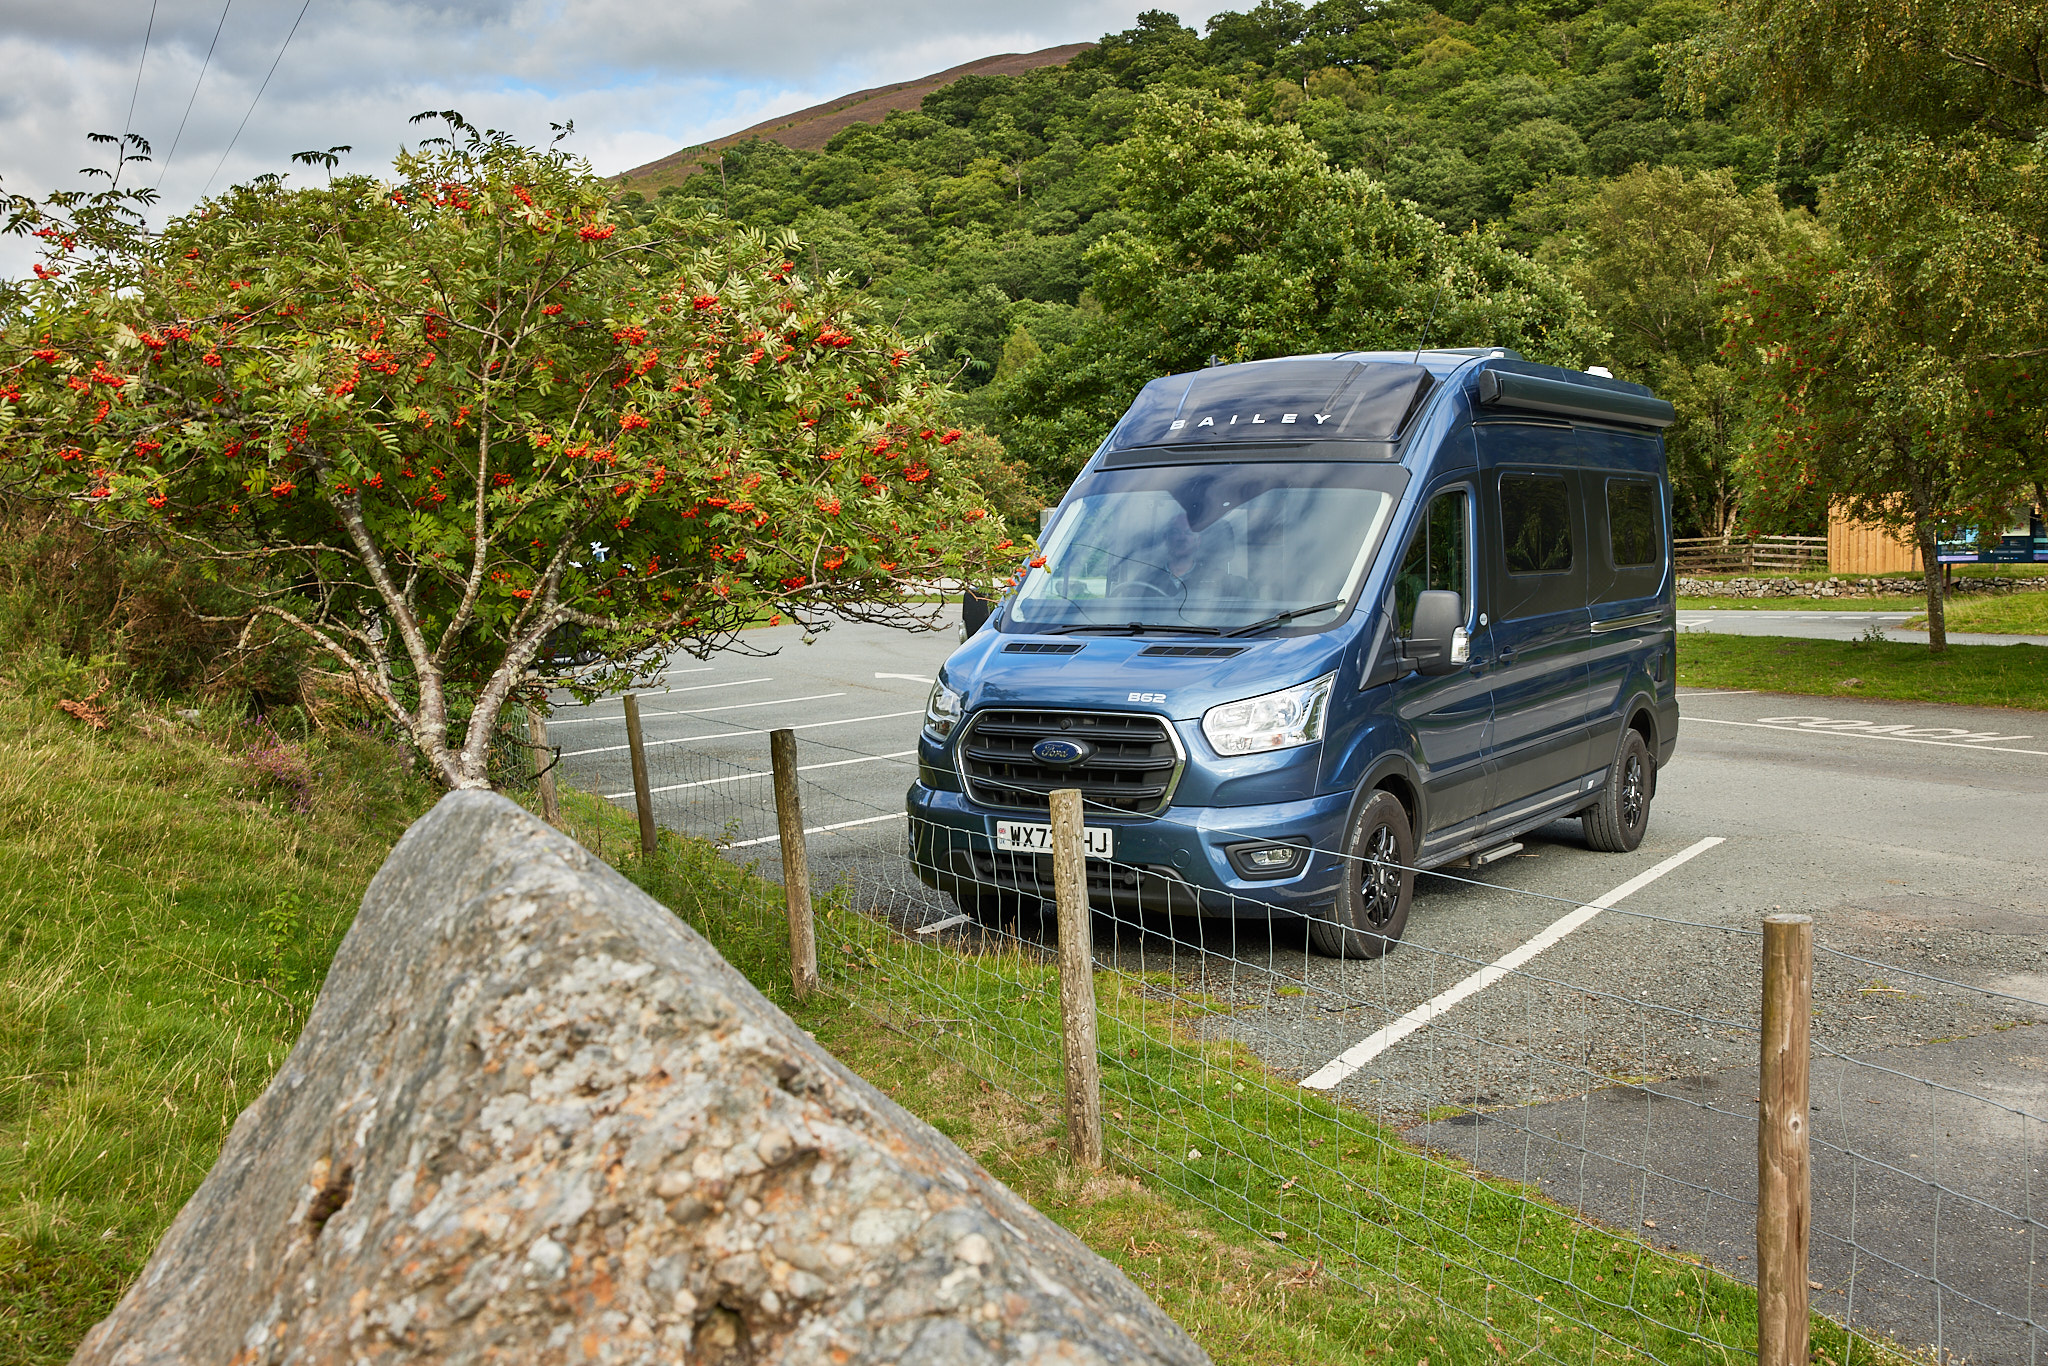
top-left (961, 711), bottom-right (1180, 815)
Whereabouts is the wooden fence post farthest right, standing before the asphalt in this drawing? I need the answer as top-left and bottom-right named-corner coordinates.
top-left (1757, 915), bottom-right (1812, 1366)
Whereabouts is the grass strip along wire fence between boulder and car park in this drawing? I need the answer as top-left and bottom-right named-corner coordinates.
top-left (567, 795), bottom-right (1886, 1364)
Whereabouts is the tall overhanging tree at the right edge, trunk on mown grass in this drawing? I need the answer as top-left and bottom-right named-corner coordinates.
top-left (1671, 0), bottom-right (2048, 649)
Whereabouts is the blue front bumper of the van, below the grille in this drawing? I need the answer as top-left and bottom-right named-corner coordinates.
top-left (907, 782), bottom-right (1352, 920)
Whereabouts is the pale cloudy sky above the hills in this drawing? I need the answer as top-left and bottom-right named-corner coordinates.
top-left (0, 0), bottom-right (1243, 274)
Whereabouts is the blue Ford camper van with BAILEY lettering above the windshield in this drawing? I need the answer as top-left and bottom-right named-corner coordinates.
top-left (909, 350), bottom-right (1677, 956)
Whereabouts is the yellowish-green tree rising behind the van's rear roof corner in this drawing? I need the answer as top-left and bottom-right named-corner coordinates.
top-left (1546, 166), bottom-right (1815, 537)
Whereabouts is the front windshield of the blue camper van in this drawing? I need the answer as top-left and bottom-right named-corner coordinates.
top-left (1006, 461), bottom-right (1407, 635)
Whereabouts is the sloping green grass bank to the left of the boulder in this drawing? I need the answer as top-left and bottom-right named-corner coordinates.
top-left (0, 688), bottom-right (426, 1366)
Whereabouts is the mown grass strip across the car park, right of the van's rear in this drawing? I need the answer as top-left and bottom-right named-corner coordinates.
top-left (1677, 631), bottom-right (2048, 711)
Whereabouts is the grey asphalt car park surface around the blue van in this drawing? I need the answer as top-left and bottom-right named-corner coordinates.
top-left (553, 612), bottom-right (2048, 1362)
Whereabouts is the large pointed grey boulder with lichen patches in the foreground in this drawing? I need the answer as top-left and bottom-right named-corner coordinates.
top-left (74, 793), bottom-right (1208, 1366)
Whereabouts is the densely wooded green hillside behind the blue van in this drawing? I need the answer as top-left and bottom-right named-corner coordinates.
top-left (629, 0), bottom-right (1831, 530)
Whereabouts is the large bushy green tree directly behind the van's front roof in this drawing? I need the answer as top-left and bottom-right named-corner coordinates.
top-left (983, 92), bottom-right (1604, 477)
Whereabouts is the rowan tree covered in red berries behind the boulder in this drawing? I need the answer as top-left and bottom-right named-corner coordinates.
top-left (0, 115), bottom-right (1008, 786)
